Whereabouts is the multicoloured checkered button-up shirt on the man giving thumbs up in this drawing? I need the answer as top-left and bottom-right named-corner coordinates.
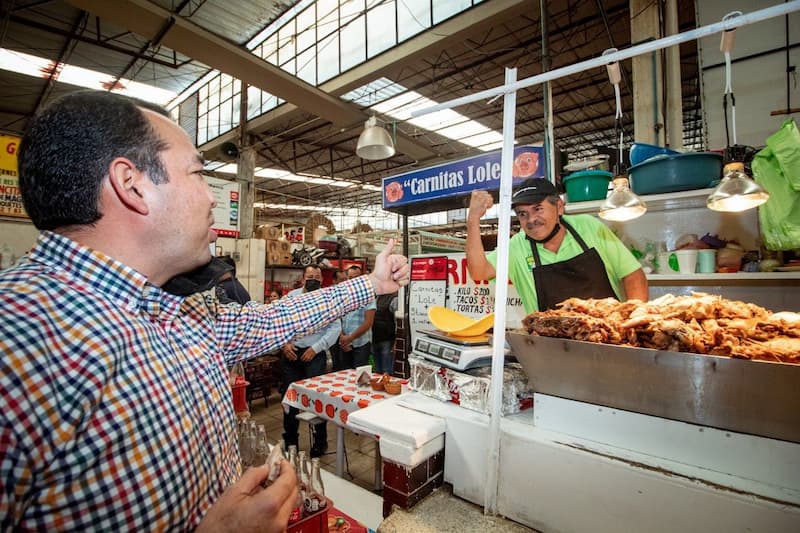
top-left (0, 232), bottom-right (373, 531)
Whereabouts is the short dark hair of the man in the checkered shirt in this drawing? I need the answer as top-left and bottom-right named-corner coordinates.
top-left (19, 91), bottom-right (169, 230)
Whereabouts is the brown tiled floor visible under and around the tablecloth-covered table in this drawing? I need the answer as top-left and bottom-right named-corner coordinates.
top-left (250, 390), bottom-right (380, 493)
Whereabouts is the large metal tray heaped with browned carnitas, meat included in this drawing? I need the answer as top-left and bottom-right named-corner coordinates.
top-left (507, 293), bottom-right (800, 443)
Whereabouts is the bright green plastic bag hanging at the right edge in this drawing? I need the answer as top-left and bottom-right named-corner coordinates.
top-left (752, 119), bottom-right (800, 250)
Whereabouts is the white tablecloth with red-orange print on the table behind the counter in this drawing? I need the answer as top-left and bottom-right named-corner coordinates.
top-left (282, 369), bottom-right (408, 426)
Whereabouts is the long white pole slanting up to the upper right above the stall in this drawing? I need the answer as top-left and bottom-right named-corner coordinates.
top-left (411, 0), bottom-right (800, 117)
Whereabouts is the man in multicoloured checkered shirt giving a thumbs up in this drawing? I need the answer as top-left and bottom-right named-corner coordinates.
top-left (0, 91), bottom-right (409, 532)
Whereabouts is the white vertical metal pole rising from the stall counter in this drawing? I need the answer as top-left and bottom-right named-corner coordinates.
top-left (483, 68), bottom-right (517, 515)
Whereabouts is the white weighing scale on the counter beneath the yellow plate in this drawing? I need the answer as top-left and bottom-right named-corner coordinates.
top-left (413, 330), bottom-right (511, 371)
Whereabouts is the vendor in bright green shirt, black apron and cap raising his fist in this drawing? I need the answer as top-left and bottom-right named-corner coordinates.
top-left (467, 178), bottom-right (648, 313)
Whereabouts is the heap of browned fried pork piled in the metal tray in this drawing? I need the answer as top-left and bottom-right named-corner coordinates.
top-left (523, 293), bottom-right (800, 364)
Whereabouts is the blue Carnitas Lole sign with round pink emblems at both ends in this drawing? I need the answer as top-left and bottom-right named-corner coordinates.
top-left (383, 146), bottom-right (545, 209)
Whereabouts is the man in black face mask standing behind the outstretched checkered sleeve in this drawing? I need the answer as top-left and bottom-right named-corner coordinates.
top-left (280, 265), bottom-right (342, 457)
